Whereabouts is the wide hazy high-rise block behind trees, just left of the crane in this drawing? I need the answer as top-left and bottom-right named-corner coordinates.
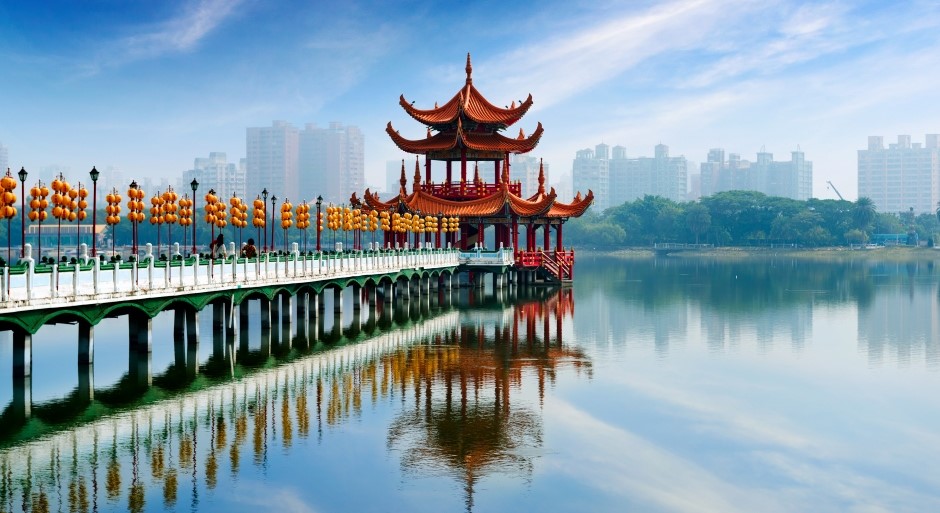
top-left (699, 148), bottom-right (813, 200)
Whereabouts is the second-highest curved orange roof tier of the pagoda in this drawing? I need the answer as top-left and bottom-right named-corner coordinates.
top-left (385, 119), bottom-right (545, 154)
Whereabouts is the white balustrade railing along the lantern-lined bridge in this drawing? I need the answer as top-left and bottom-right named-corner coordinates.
top-left (0, 244), bottom-right (462, 315)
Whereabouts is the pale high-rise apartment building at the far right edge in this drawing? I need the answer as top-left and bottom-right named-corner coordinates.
top-left (858, 134), bottom-right (940, 214)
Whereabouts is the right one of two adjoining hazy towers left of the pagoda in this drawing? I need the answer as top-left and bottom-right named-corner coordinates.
top-left (297, 122), bottom-right (366, 203)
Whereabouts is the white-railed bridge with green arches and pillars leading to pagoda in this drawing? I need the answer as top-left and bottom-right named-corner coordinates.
top-left (0, 245), bottom-right (540, 419)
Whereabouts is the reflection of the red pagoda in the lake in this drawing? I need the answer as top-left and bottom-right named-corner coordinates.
top-left (385, 290), bottom-right (591, 511)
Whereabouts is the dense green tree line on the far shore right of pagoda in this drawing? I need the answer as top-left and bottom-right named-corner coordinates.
top-left (565, 191), bottom-right (940, 248)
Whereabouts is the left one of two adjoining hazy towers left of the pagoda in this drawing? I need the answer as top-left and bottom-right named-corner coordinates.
top-left (246, 121), bottom-right (298, 202)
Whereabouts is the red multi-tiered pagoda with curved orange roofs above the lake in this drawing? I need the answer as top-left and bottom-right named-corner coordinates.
top-left (363, 54), bottom-right (594, 281)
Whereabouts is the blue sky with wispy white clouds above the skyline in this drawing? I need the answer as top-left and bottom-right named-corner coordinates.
top-left (0, 0), bottom-right (940, 199)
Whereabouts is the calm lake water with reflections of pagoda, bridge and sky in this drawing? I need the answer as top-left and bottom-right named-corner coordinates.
top-left (0, 256), bottom-right (940, 512)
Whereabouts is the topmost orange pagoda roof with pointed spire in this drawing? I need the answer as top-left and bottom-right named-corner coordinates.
top-left (398, 53), bottom-right (532, 127)
